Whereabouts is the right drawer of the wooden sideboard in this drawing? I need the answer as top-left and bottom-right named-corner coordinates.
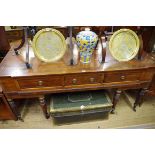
top-left (104, 72), bottom-right (141, 82)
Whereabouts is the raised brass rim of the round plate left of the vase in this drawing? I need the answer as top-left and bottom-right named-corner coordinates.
top-left (32, 28), bottom-right (66, 62)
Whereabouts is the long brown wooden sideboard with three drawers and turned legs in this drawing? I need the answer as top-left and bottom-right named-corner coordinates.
top-left (0, 38), bottom-right (155, 120)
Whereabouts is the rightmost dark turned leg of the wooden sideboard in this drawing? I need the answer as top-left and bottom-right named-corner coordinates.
top-left (133, 88), bottom-right (148, 111)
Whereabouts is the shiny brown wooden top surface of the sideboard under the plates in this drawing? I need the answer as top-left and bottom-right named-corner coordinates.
top-left (0, 39), bottom-right (155, 77)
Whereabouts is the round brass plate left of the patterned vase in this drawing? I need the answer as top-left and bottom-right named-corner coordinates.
top-left (32, 28), bottom-right (66, 62)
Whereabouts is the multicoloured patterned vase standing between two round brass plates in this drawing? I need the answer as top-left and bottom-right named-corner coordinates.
top-left (76, 29), bottom-right (98, 63)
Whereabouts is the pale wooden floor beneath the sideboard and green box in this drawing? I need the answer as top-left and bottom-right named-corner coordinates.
top-left (0, 91), bottom-right (155, 129)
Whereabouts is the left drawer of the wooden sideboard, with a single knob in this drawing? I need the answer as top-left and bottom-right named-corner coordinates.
top-left (17, 76), bottom-right (64, 89)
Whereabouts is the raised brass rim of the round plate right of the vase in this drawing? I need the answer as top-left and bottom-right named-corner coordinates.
top-left (109, 29), bottom-right (140, 61)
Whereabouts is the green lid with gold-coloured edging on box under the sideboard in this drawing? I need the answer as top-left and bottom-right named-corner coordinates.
top-left (50, 90), bottom-right (112, 117)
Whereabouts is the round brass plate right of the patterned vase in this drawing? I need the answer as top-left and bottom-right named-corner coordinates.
top-left (109, 29), bottom-right (139, 61)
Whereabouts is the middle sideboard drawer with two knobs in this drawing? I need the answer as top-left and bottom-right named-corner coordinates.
top-left (65, 73), bottom-right (104, 86)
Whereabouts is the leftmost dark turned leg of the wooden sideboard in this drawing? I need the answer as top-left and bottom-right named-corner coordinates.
top-left (7, 99), bottom-right (24, 122)
